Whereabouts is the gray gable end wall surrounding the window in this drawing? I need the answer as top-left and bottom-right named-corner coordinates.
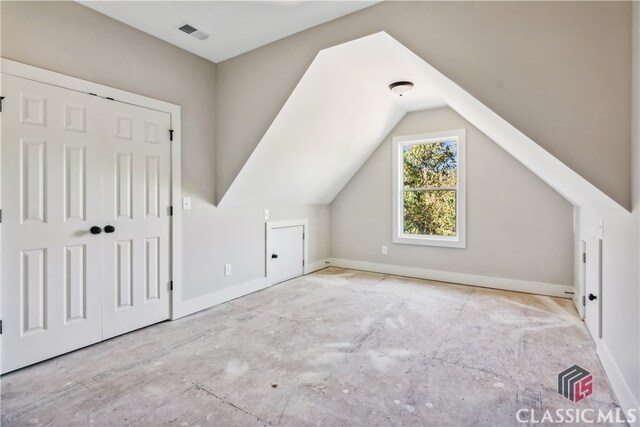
top-left (331, 108), bottom-right (573, 286)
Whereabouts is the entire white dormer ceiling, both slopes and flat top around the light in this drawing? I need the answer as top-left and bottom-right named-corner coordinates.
top-left (219, 32), bottom-right (625, 211)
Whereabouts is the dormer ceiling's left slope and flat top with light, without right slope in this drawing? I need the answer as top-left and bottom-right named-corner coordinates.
top-left (220, 33), bottom-right (445, 206)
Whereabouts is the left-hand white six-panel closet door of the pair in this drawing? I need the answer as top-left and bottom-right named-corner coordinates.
top-left (2, 75), bottom-right (103, 372)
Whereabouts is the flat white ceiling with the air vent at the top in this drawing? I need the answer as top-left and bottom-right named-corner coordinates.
top-left (78, 0), bottom-right (381, 62)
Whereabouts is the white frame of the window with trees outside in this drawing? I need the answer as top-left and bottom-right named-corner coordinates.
top-left (392, 129), bottom-right (467, 248)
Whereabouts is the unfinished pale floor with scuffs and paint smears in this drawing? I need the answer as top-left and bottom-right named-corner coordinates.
top-left (2, 268), bottom-right (616, 426)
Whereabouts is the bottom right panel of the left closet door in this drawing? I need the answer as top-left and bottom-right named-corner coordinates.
top-left (64, 245), bottom-right (87, 322)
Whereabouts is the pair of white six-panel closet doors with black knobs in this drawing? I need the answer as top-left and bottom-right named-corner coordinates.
top-left (1, 74), bottom-right (171, 372)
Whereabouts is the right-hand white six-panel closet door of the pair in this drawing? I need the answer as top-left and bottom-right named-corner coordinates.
top-left (102, 102), bottom-right (171, 339)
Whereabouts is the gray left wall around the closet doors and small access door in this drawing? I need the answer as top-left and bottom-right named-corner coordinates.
top-left (0, 1), bottom-right (329, 299)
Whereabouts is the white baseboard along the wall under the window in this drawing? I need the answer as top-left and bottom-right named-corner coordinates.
top-left (329, 258), bottom-right (574, 298)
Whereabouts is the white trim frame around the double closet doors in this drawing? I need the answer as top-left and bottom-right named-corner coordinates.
top-left (0, 58), bottom-right (183, 320)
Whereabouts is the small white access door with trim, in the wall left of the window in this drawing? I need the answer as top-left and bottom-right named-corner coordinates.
top-left (266, 221), bottom-right (307, 285)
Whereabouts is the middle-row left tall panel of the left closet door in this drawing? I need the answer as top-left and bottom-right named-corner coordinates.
top-left (20, 140), bottom-right (47, 226)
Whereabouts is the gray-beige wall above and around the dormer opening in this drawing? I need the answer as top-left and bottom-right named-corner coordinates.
top-left (216, 1), bottom-right (631, 211)
